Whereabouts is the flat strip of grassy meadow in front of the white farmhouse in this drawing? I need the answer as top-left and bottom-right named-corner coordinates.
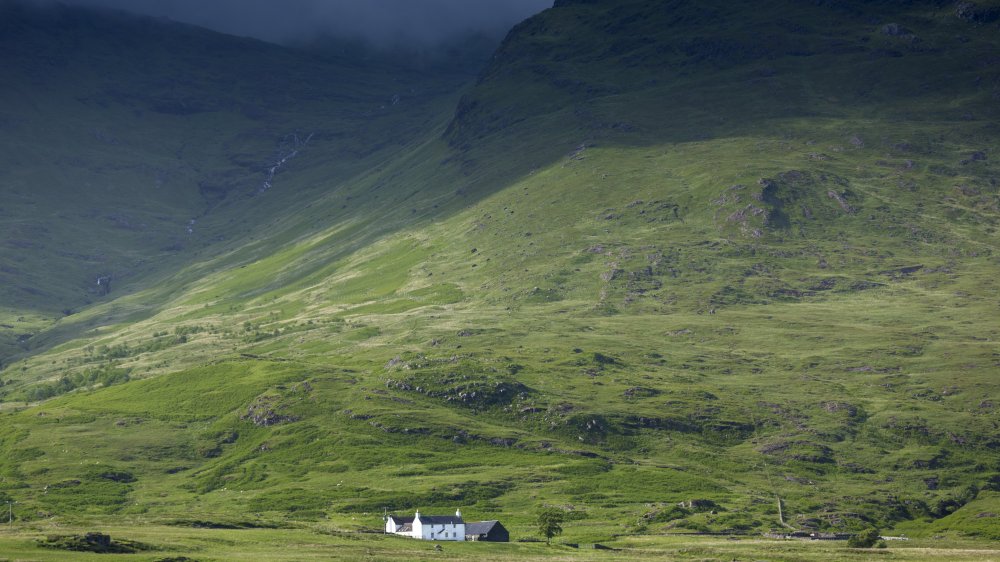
top-left (0, 526), bottom-right (1000, 562)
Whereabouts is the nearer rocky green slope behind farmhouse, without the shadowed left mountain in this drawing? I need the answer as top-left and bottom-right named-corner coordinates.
top-left (0, 2), bottom-right (1000, 552)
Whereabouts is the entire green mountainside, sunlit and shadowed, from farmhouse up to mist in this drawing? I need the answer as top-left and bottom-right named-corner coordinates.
top-left (0, 0), bottom-right (1000, 559)
